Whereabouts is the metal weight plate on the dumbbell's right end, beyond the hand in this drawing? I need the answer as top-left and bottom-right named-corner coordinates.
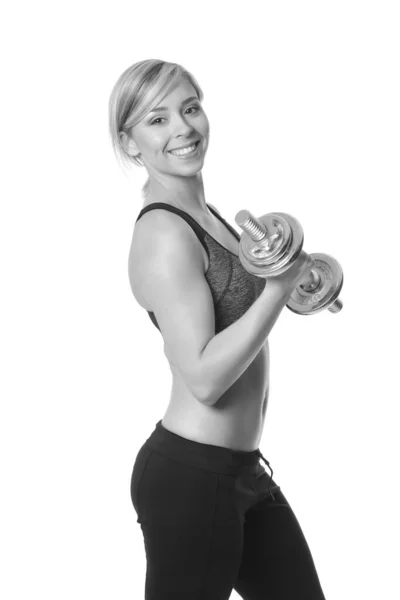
top-left (286, 252), bottom-right (343, 315)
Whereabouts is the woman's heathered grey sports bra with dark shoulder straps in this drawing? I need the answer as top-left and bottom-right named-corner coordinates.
top-left (136, 202), bottom-right (266, 334)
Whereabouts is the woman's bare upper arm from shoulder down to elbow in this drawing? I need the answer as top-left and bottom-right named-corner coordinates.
top-left (135, 210), bottom-right (215, 398)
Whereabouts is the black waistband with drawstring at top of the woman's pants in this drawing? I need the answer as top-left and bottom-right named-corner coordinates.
top-left (145, 419), bottom-right (274, 498)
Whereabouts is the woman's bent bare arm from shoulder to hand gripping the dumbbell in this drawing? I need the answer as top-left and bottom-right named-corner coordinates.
top-left (136, 211), bottom-right (309, 406)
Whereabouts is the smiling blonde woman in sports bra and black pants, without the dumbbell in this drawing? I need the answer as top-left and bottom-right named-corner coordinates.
top-left (109, 60), bottom-right (324, 600)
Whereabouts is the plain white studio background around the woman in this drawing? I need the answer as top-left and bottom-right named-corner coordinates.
top-left (0, 0), bottom-right (400, 600)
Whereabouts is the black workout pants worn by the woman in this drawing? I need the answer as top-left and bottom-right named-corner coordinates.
top-left (131, 421), bottom-right (325, 600)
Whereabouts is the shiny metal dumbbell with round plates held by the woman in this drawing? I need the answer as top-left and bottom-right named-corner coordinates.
top-left (235, 210), bottom-right (343, 315)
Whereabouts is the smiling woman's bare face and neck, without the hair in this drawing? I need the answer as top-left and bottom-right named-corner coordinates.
top-left (120, 78), bottom-right (210, 217)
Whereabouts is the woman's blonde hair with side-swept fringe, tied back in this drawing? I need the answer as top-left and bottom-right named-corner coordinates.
top-left (108, 59), bottom-right (204, 197)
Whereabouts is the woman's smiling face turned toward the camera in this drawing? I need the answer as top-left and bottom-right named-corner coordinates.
top-left (122, 79), bottom-right (210, 179)
